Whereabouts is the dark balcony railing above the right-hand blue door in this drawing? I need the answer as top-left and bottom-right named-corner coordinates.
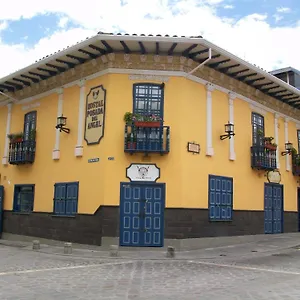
top-left (251, 146), bottom-right (277, 170)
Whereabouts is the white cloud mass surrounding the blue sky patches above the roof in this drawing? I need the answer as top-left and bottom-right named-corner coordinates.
top-left (0, 0), bottom-right (300, 77)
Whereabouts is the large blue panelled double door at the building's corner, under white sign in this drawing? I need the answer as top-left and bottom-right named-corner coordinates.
top-left (120, 183), bottom-right (165, 247)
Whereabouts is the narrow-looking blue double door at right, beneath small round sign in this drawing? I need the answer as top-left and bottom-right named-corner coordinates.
top-left (264, 183), bottom-right (283, 234)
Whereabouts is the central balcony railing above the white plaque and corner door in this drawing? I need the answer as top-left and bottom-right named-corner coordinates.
top-left (124, 125), bottom-right (170, 155)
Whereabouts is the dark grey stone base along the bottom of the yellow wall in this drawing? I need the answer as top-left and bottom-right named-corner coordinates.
top-left (3, 206), bottom-right (298, 245)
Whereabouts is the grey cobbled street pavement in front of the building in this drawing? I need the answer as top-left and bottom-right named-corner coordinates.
top-left (0, 235), bottom-right (300, 300)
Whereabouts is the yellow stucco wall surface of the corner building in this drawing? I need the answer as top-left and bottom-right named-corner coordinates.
top-left (0, 74), bottom-right (297, 213)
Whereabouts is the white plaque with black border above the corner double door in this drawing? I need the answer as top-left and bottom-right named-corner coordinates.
top-left (126, 164), bottom-right (160, 181)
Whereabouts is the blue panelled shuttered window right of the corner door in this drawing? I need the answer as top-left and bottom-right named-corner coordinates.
top-left (208, 175), bottom-right (233, 221)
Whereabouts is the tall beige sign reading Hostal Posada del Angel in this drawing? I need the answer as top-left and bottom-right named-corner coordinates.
top-left (84, 85), bottom-right (106, 145)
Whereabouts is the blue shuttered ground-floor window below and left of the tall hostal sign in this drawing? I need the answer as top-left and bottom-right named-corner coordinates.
top-left (53, 182), bottom-right (78, 216)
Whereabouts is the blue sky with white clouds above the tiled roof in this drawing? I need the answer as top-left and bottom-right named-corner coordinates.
top-left (0, 0), bottom-right (300, 77)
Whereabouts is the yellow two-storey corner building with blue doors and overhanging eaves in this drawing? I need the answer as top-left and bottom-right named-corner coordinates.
top-left (0, 33), bottom-right (300, 247)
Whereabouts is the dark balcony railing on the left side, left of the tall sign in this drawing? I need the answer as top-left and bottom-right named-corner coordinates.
top-left (8, 140), bottom-right (36, 165)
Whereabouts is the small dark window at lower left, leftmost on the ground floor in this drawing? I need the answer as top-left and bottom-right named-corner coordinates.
top-left (13, 184), bottom-right (34, 213)
